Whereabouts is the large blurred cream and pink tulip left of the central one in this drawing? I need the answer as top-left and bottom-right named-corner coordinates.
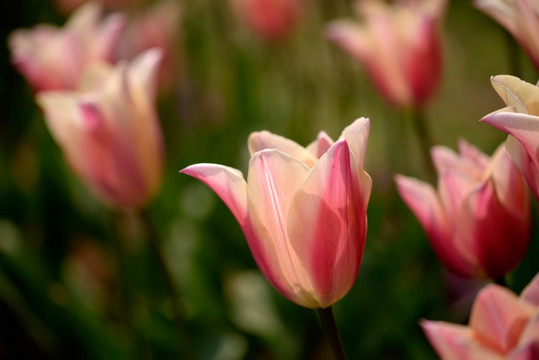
top-left (37, 49), bottom-right (163, 208)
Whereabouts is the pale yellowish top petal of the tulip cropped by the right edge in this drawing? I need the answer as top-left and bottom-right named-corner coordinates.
top-left (490, 75), bottom-right (539, 115)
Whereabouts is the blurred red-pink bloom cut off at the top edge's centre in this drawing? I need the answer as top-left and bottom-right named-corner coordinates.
top-left (231, 0), bottom-right (304, 40)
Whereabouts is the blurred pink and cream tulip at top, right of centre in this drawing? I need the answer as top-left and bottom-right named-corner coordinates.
top-left (327, 0), bottom-right (447, 108)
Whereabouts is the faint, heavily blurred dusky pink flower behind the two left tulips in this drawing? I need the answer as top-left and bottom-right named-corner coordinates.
top-left (117, 0), bottom-right (181, 89)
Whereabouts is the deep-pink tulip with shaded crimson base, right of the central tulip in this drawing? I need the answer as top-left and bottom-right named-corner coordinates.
top-left (396, 140), bottom-right (531, 279)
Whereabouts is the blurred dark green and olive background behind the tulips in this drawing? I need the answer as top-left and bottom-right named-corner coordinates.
top-left (0, 0), bottom-right (539, 360)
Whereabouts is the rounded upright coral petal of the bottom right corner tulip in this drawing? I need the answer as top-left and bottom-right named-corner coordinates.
top-left (470, 284), bottom-right (534, 354)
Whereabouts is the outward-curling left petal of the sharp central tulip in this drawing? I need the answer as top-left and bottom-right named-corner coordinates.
top-left (180, 164), bottom-right (248, 228)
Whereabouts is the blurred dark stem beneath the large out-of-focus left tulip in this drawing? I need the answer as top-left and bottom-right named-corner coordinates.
top-left (140, 211), bottom-right (197, 359)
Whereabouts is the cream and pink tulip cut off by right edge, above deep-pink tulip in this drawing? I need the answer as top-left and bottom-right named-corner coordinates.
top-left (481, 75), bottom-right (539, 201)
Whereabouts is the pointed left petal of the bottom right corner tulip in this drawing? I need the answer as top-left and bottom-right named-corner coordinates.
top-left (421, 320), bottom-right (503, 360)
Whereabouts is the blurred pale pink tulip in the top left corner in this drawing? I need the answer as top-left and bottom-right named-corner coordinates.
top-left (9, 3), bottom-right (125, 92)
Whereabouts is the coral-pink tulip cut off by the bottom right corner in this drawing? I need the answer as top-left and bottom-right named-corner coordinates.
top-left (421, 275), bottom-right (539, 360)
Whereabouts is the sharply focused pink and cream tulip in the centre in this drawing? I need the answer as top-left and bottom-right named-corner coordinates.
top-left (181, 118), bottom-right (371, 308)
